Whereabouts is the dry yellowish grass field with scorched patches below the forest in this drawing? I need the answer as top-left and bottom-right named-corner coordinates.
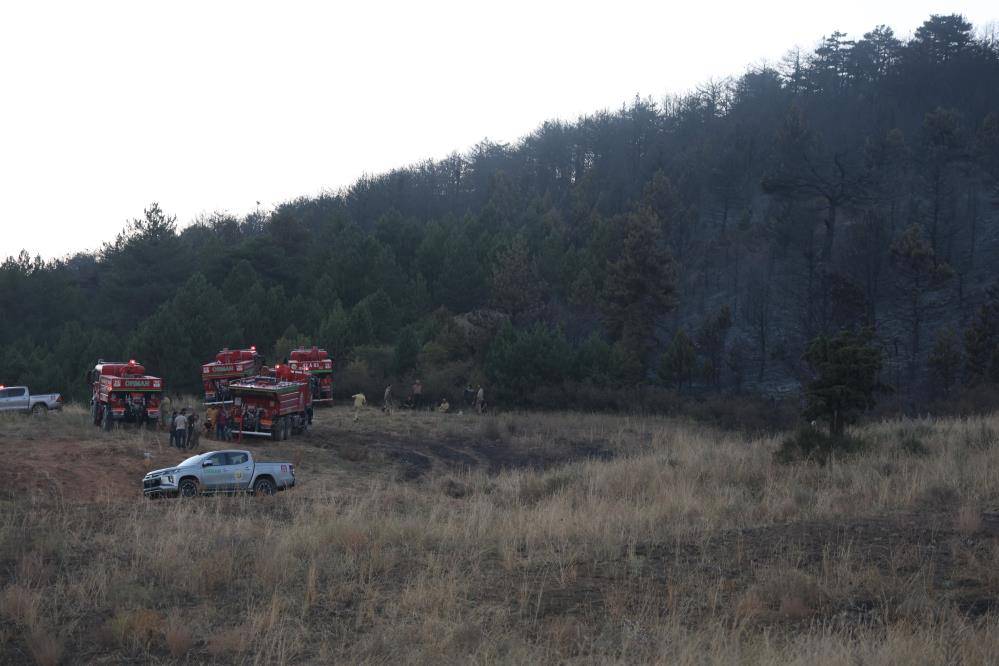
top-left (0, 408), bottom-right (999, 664)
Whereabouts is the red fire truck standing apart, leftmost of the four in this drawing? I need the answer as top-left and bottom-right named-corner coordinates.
top-left (87, 359), bottom-right (163, 430)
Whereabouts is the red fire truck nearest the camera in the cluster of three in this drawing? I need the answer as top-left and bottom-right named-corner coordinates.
top-left (227, 365), bottom-right (312, 441)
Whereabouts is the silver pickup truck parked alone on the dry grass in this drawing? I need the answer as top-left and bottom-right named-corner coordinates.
top-left (142, 450), bottom-right (295, 497)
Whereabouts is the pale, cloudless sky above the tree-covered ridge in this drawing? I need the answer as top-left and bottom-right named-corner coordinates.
top-left (0, 0), bottom-right (999, 258)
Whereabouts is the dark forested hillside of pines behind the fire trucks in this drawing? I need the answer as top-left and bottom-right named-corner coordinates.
top-left (0, 16), bottom-right (999, 405)
